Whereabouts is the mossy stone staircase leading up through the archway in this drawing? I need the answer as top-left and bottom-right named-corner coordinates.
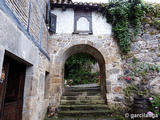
top-left (54, 86), bottom-right (115, 120)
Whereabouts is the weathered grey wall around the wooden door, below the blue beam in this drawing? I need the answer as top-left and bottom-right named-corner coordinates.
top-left (0, 10), bottom-right (50, 120)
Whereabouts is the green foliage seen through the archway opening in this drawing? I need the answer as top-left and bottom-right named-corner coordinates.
top-left (65, 53), bottom-right (98, 85)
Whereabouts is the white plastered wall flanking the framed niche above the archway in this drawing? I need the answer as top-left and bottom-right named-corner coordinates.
top-left (52, 8), bottom-right (112, 35)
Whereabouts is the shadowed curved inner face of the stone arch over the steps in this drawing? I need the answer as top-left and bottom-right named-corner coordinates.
top-left (53, 44), bottom-right (106, 98)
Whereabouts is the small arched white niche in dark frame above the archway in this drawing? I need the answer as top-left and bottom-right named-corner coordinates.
top-left (73, 10), bottom-right (92, 34)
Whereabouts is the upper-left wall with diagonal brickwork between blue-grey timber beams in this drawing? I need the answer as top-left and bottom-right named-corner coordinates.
top-left (0, 0), bottom-right (49, 54)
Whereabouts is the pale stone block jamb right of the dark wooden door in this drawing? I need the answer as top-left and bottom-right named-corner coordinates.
top-left (22, 66), bottom-right (38, 120)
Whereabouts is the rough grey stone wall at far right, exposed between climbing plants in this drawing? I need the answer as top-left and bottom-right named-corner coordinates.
top-left (129, 24), bottom-right (160, 94)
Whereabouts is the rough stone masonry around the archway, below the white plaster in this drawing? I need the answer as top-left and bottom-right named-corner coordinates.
top-left (49, 34), bottom-right (124, 106)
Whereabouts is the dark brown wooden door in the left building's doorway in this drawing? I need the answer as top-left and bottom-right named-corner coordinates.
top-left (1, 58), bottom-right (26, 120)
